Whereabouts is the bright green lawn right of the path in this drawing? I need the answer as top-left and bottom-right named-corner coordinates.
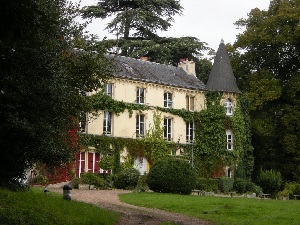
top-left (120, 193), bottom-right (300, 225)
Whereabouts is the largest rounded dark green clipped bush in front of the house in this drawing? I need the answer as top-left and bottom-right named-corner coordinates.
top-left (147, 158), bottom-right (196, 194)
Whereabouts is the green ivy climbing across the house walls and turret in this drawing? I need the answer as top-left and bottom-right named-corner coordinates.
top-left (79, 92), bottom-right (253, 178)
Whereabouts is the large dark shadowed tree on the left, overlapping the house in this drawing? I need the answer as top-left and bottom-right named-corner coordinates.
top-left (0, 0), bottom-right (112, 187)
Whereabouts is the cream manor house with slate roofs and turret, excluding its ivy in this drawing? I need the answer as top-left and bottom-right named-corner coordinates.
top-left (76, 41), bottom-right (239, 177)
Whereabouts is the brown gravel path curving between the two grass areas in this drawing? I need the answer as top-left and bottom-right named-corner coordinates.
top-left (49, 188), bottom-right (212, 225)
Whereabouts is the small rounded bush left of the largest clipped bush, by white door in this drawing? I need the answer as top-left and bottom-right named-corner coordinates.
top-left (114, 168), bottom-right (140, 189)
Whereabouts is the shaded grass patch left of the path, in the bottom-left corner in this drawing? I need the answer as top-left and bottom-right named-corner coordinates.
top-left (0, 188), bottom-right (120, 225)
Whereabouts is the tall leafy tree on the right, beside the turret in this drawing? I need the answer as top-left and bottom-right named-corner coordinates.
top-left (234, 0), bottom-right (300, 180)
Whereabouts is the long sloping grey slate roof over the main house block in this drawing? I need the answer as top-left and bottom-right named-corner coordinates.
top-left (107, 55), bottom-right (206, 90)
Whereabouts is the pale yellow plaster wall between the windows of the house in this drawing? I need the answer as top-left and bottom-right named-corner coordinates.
top-left (87, 75), bottom-right (205, 143)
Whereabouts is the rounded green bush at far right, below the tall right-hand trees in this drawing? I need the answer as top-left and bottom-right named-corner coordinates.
top-left (257, 170), bottom-right (282, 195)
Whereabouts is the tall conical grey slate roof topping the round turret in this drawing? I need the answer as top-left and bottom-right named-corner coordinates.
top-left (206, 40), bottom-right (239, 93)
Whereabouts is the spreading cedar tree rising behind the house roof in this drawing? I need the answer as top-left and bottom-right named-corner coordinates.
top-left (82, 0), bottom-right (211, 68)
